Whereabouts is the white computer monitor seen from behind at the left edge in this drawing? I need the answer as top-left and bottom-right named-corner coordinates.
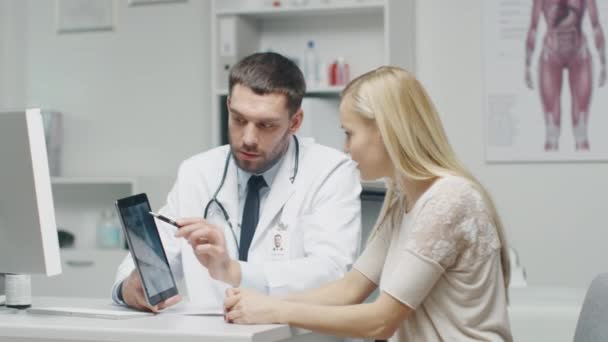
top-left (0, 109), bottom-right (61, 284)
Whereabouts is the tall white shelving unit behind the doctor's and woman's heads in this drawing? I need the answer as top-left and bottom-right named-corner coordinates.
top-left (211, 0), bottom-right (416, 199)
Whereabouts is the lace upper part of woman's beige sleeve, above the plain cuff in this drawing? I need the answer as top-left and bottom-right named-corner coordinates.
top-left (405, 178), bottom-right (500, 270)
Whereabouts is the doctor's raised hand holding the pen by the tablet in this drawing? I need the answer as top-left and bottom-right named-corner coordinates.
top-left (175, 217), bottom-right (241, 286)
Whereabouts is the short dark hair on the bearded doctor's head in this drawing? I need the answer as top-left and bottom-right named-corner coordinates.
top-left (228, 52), bottom-right (306, 116)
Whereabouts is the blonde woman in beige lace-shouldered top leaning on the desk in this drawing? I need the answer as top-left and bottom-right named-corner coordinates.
top-left (224, 67), bottom-right (512, 341)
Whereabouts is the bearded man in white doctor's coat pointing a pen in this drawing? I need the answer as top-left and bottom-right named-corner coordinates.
top-left (112, 52), bottom-right (361, 311)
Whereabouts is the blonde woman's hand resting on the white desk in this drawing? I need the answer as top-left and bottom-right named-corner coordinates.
top-left (224, 288), bottom-right (288, 324)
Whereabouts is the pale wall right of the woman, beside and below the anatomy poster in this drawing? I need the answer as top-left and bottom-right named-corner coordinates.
top-left (417, 0), bottom-right (608, 287)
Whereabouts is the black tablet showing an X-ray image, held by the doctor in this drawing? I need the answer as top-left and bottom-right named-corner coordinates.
top-left (116, 194), bottom-right (177, 305)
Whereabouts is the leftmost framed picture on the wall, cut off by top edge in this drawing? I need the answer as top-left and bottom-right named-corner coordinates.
top-left (56, 0), bottom-right (114, 33)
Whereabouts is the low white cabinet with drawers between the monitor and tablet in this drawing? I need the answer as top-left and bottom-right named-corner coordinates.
top-left (32, 177), bottom-right (137, 298)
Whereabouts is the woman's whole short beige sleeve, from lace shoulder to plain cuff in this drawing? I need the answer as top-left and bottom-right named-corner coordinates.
top-left (380, 177), bottom-right (500, 309)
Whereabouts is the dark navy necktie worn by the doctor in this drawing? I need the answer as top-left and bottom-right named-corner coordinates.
top-left (239, 176), bottom-right (266, 261)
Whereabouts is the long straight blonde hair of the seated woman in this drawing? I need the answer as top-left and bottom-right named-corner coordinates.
top-left (342, 66), bottom-right (510, 287)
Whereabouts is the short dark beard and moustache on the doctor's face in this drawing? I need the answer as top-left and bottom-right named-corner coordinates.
top-left (230, 129), bottom-right (291, 175)
